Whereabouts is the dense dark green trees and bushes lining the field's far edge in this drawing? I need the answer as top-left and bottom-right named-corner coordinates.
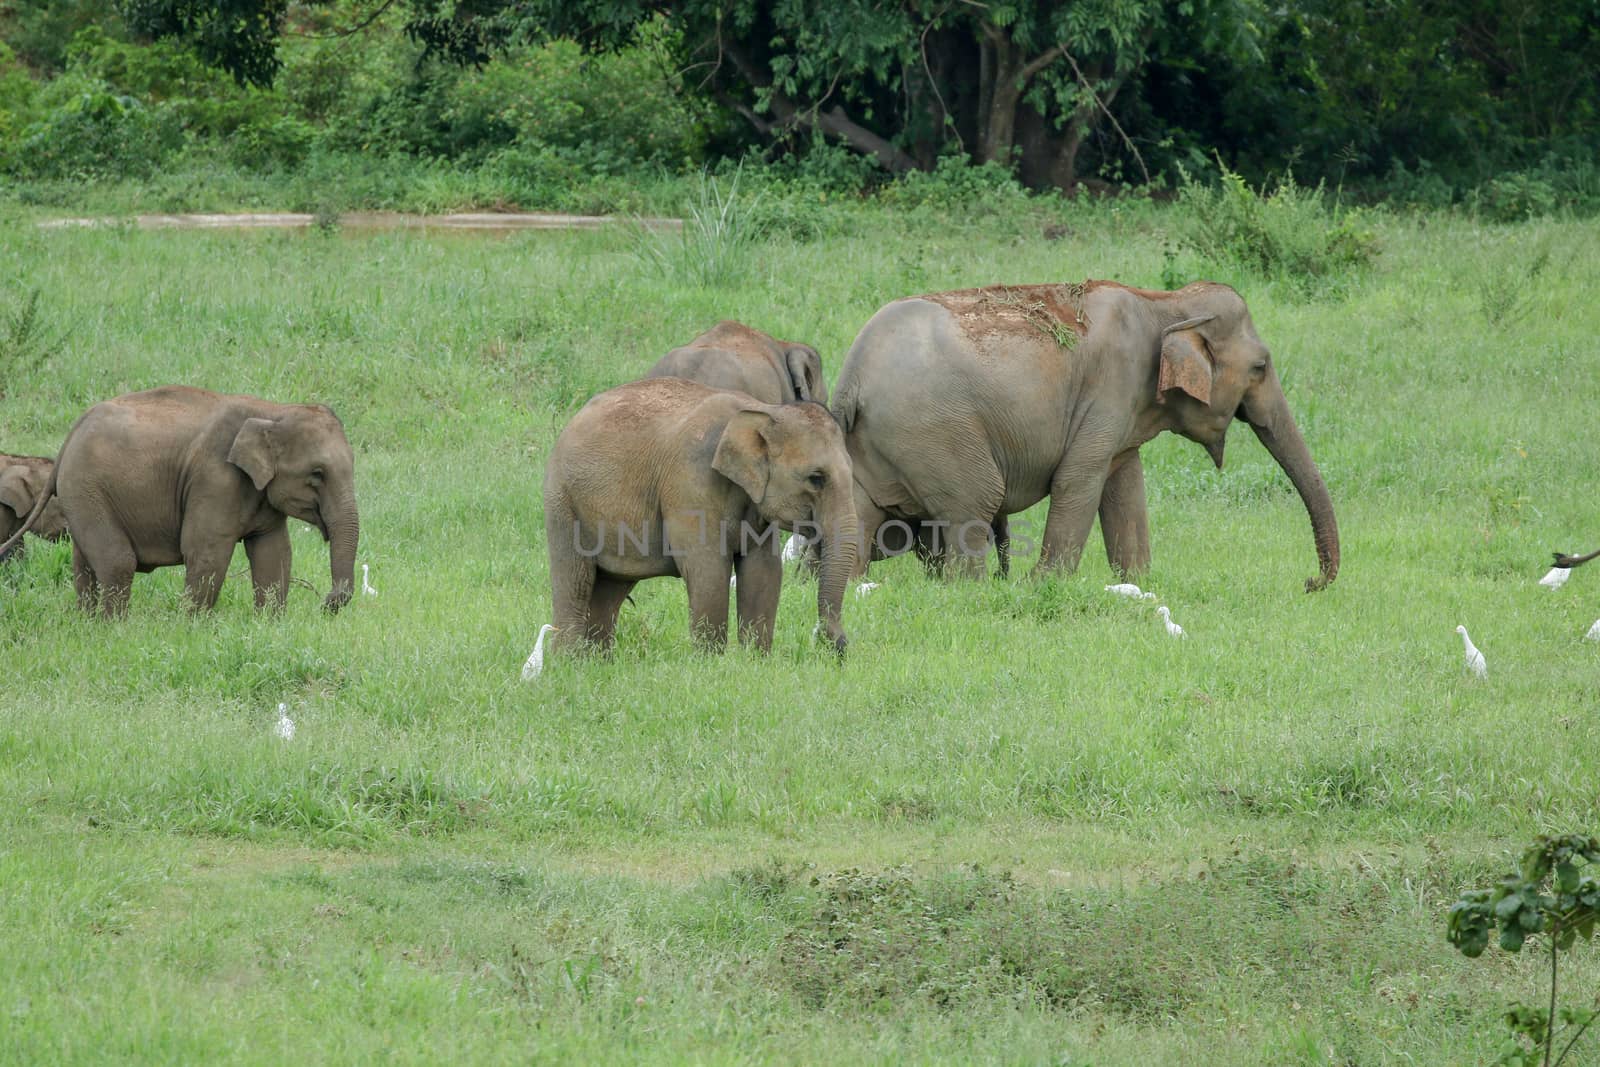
top-left (0, 0), bottom-right (1600, 211)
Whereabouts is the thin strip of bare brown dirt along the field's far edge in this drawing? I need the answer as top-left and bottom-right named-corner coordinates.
top-left (38, 211), bottom-right (683, 232)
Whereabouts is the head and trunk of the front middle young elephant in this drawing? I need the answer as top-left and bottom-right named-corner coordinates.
top-left (712, 403), bottom-right (859, 651)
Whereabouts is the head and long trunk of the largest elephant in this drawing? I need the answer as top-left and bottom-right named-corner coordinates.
top-left (1155, 282), bottom-right (1339, 592)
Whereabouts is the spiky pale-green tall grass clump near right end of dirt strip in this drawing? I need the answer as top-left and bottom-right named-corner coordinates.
top-left (634, 173), bottom-right (765, 288)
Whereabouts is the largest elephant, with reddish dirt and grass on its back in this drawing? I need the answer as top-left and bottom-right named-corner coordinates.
top-left (834, 282), bottom-right (1339, 590)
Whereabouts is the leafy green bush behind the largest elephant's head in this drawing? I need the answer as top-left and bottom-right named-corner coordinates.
top-left (1178, 165), bottom-right (1378, 286)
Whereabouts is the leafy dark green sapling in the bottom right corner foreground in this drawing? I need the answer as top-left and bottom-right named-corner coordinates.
top-left (1448, 833), bottom-right (1600, 1067)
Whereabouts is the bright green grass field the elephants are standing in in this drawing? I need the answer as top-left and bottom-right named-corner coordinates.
top-left (0, 205), bottom-right (1600, 1065)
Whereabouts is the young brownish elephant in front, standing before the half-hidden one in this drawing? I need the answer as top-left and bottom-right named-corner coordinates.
top-left (544, 378), bottom-right (858, 653)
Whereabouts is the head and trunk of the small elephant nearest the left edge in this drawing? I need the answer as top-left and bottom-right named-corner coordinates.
top-left (227, 405), bottom-right (362, 611)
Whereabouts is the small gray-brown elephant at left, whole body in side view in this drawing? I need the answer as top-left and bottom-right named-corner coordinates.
top-left (0, 386), bottom-right (360, 617)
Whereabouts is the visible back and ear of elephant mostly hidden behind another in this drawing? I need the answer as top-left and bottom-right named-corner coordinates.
top-left (645, 318), bottom-right (827, 406)
